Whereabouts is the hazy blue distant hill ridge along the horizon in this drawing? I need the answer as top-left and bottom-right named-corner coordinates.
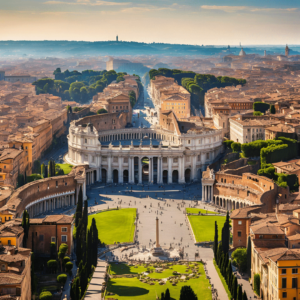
top-left (0, 41), bottom-right (300, 58)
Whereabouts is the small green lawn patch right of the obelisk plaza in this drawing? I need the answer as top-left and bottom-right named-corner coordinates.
top-left (188, 216), bottom-right (226, 242)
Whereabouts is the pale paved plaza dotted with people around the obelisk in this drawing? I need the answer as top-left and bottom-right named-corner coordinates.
top-left (82, 183), bottom-right (227, 299)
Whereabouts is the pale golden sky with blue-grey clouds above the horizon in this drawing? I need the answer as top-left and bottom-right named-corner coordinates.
top-left (0, 0), bottom-right (300, 45)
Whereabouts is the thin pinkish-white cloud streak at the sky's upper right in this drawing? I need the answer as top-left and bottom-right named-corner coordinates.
top-left (200, 5), bottom-right (298, 13)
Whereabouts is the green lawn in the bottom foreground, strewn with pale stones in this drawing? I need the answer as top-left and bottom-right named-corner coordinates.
top-left (106, 263), bottom-right (212, 300)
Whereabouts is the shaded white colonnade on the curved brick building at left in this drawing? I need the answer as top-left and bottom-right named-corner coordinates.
top-left (26, 192), bottom-right (76, 218)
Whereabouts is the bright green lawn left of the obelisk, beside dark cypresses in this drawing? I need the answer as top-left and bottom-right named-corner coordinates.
top-left (88, 208), bottom-right (136, 245)
